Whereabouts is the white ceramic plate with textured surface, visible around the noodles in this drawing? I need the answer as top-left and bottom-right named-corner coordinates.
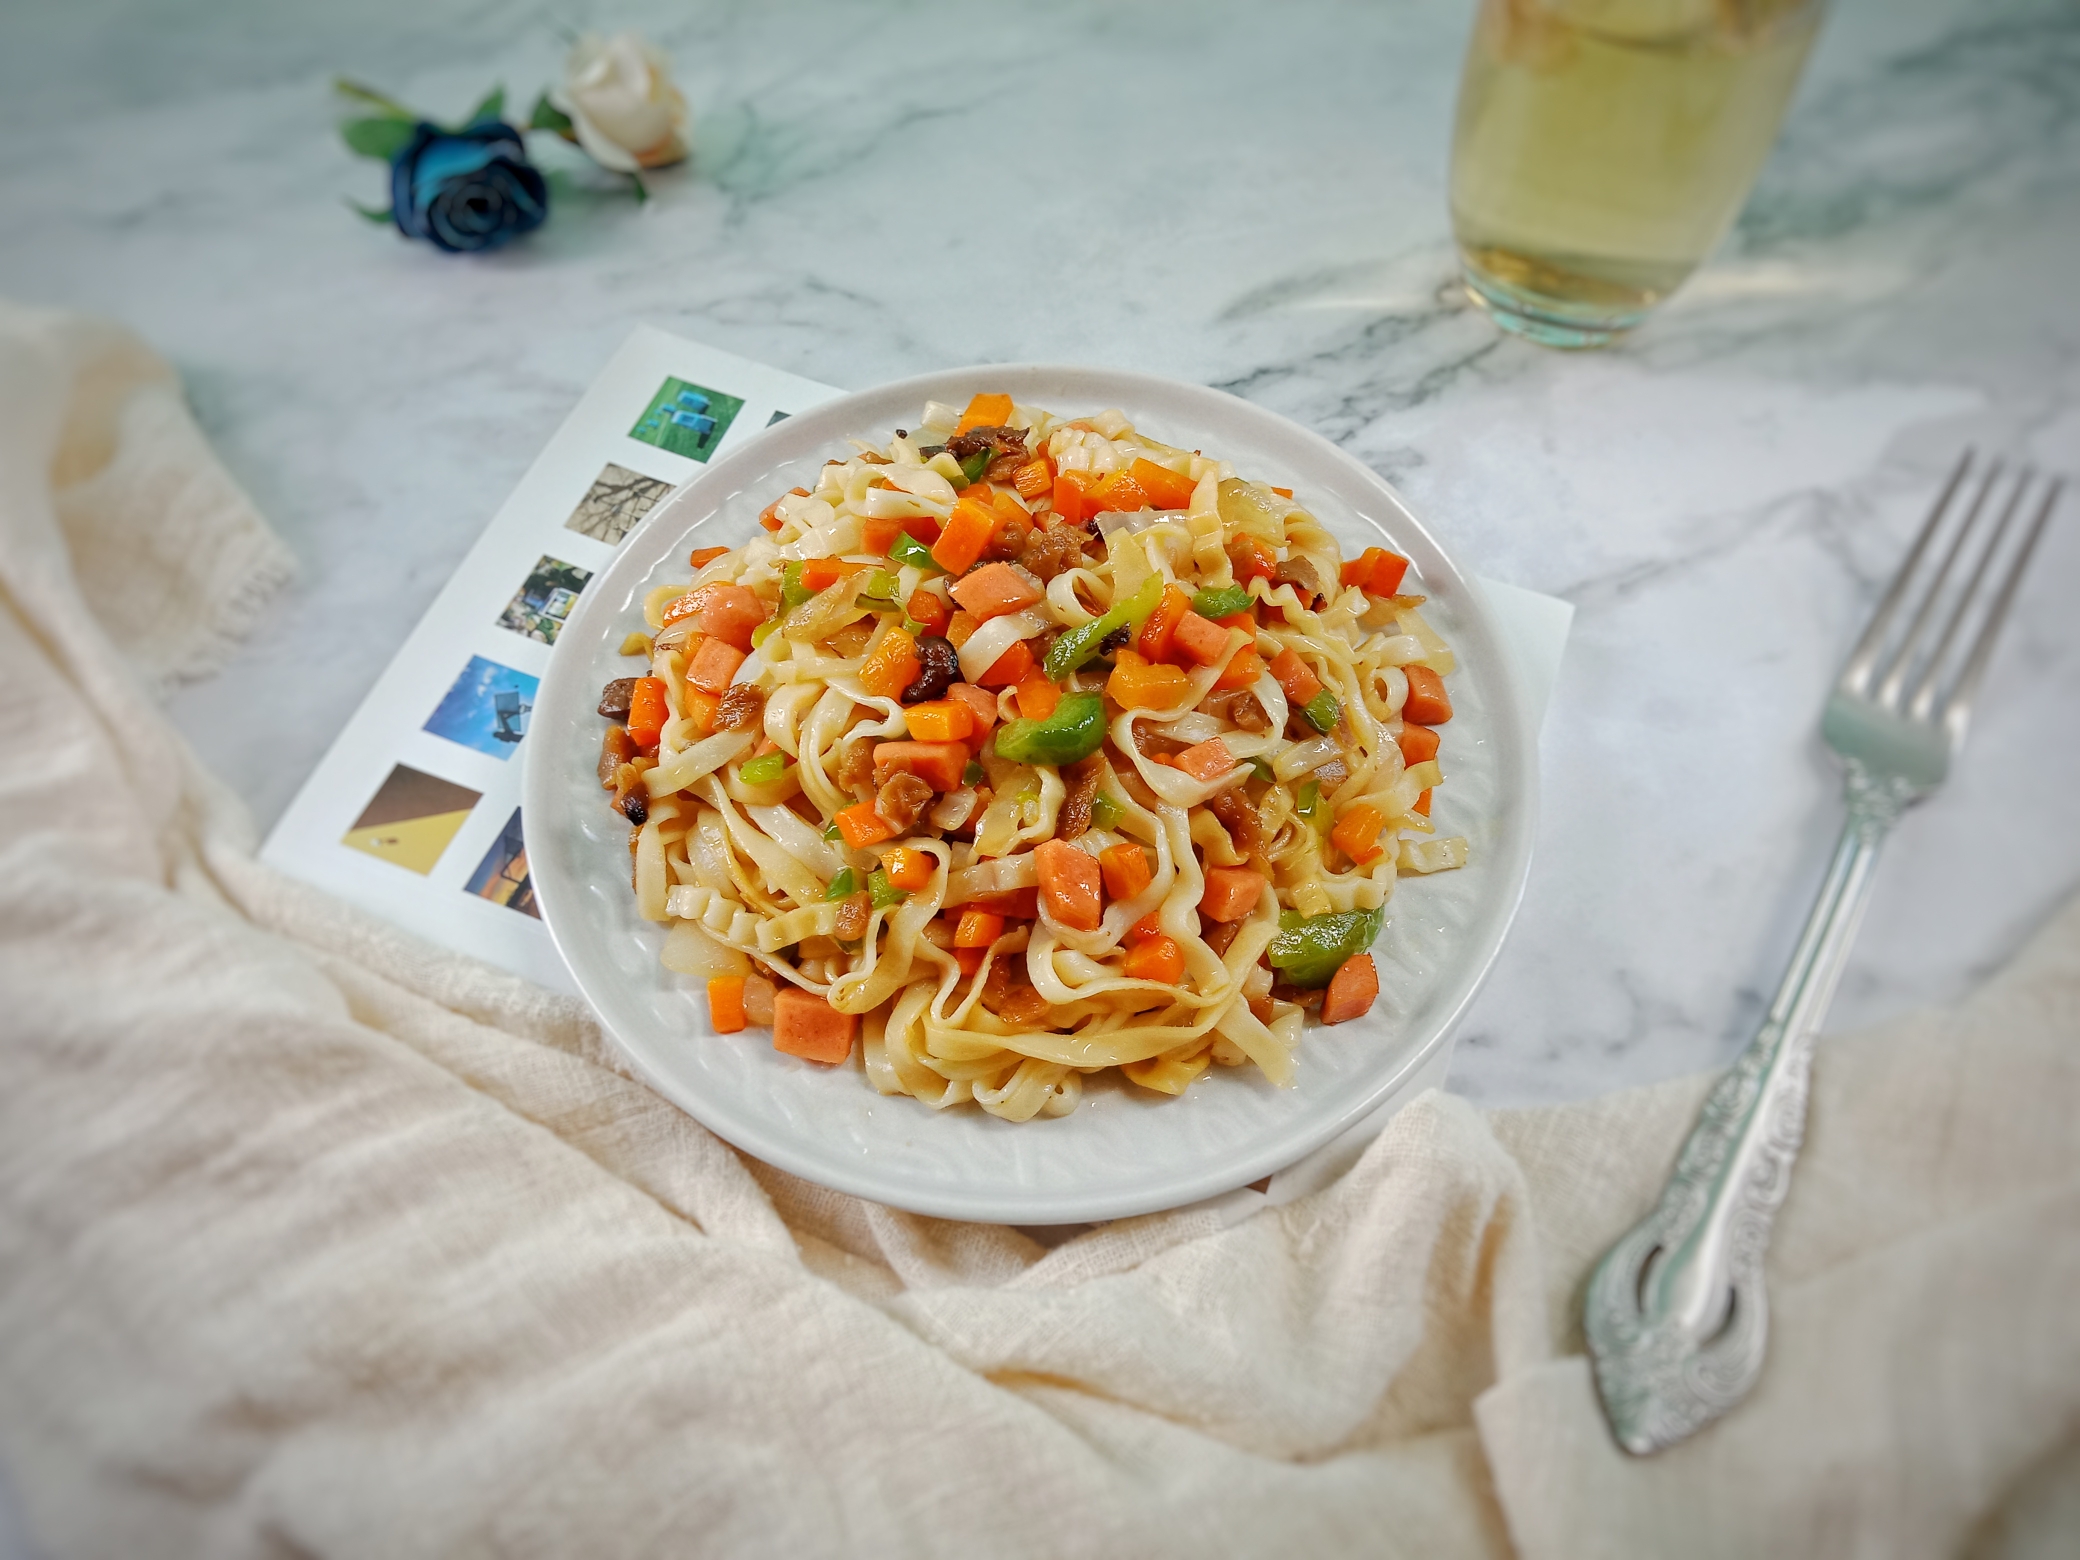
top-left (522, 366), bottom-right (1537, 1225)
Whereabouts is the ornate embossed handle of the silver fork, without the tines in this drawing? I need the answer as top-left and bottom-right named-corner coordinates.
top-left (1583, 765), bottom-right (1909, 1452)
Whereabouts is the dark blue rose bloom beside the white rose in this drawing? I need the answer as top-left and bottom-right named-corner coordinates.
top-left (391, 119), bottom-right (549, 254)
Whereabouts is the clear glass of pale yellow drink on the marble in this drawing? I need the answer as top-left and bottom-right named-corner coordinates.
top-left (1452, 0), bottom-right (1822, 347)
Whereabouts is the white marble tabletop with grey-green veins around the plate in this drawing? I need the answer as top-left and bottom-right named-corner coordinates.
top-left (0, 0), bottom-right (2080, 1102)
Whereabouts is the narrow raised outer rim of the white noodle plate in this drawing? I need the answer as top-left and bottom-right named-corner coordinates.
top-left (520, 362), bottom-right (1539, 1225)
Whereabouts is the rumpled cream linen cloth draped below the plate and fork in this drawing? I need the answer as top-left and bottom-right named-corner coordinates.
top-left (0, 308), bottom-right (2080, 1556)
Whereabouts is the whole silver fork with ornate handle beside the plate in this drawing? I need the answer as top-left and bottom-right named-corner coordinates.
top-left (1583, 449), bottom-right (2063, 1452)
